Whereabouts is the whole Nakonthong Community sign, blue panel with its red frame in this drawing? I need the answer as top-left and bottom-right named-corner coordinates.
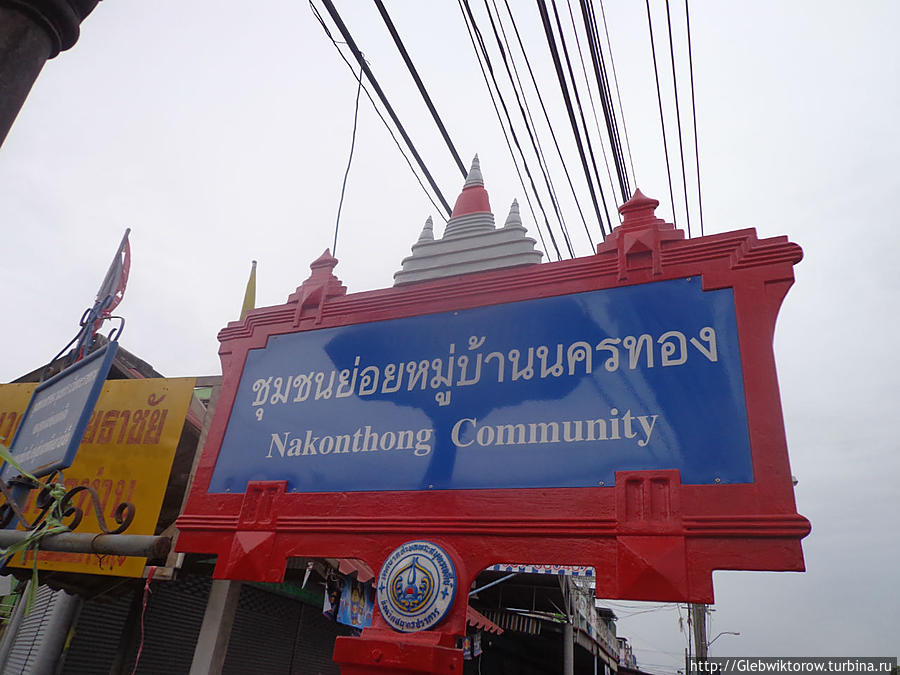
top-left (177, 192), bottom-right (809, 648)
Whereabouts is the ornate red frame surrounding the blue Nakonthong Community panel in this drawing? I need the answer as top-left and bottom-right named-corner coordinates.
top-left (176, 192), bottom-right (810, 646)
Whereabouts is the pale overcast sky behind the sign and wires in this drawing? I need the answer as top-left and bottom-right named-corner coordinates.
top-left (0, 0), bottom-right (900, 672)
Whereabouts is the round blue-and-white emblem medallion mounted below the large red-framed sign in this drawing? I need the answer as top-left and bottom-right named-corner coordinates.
top-left (376, 540), bottom-right (456, 633)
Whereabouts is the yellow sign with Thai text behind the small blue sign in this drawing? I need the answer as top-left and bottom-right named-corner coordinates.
top-left (0, 377), bottom-right (194, 577)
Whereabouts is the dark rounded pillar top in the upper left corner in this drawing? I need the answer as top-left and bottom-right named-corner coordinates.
top-left (0, 0), bottom-right (99, 145)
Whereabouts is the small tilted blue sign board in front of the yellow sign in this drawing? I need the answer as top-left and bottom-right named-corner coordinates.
top-left (2, 342), bottom-right (119, 479)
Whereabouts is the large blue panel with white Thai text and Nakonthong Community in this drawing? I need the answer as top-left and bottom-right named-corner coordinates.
top-left (209, 277), bottom-right (753, 493)
